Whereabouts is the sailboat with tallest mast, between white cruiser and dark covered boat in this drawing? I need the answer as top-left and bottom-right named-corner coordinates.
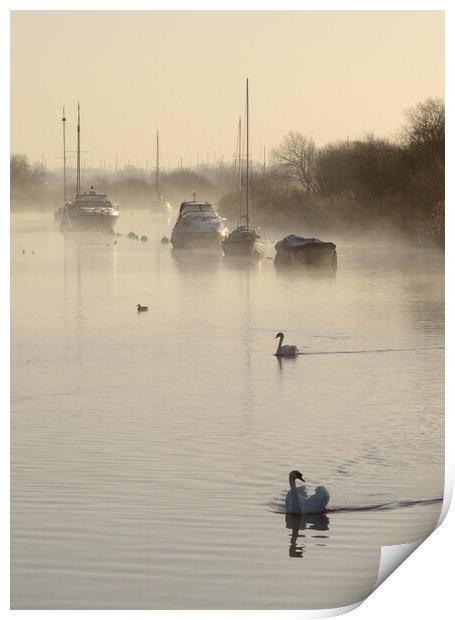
top-left (222, 79), bottom-right (262, 257)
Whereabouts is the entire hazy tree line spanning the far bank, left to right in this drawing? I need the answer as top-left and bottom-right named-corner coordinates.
top-left (11, 98), bottom-right (445, 244)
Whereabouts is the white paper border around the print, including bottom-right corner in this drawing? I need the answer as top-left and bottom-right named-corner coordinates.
top-left (0, 0), bottom-right (455, 620)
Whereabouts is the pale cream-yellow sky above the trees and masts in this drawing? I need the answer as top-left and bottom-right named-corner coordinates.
top-left (11, 11), bottom-right (444, 168)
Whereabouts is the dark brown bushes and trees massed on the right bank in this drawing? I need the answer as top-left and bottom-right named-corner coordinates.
top-left (264, 98), bottom-right (445, 241)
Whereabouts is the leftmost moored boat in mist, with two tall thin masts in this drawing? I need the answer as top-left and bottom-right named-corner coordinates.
top-left (55, 102), bottom-right (119, 232)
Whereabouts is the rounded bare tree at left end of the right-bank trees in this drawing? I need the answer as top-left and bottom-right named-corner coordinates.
top-left (272, 131), bottom-right (318, 192)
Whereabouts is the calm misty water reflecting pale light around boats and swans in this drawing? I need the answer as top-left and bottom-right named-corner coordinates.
top-left (11, 210), bottom-right (444, 609)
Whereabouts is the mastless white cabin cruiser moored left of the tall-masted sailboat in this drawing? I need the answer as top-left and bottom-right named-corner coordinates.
top-left (171, 194), bottom-right (227, 248)
